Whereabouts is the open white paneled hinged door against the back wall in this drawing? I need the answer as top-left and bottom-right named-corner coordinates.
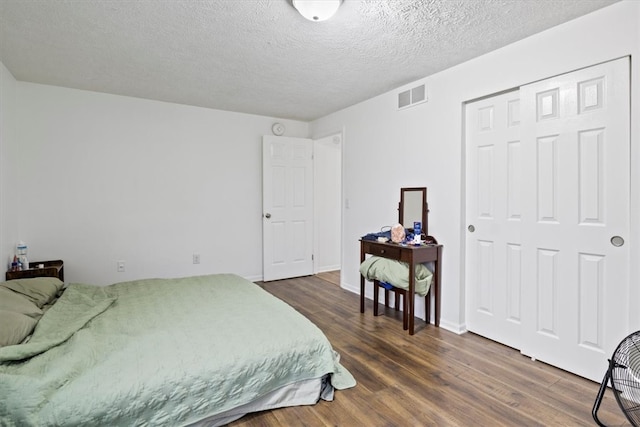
top-left (262, 136), bottom-right (313, 281)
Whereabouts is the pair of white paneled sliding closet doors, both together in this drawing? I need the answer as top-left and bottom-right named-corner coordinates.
top-left (466, 58), bottom-right (630, 381)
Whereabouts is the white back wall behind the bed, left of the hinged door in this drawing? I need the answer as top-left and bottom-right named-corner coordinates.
top-left (9, 82), bottom-right (309, 285)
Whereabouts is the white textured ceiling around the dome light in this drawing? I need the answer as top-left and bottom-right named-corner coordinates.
top-left (0, 0), bottom-right (617, 120)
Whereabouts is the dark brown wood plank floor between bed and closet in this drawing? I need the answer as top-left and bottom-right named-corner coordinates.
top-left (231, 276), bottom-right (629, 427)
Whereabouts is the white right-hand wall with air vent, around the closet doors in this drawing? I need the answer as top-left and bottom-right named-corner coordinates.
top-left (311, 1), bottom-right (640, 331)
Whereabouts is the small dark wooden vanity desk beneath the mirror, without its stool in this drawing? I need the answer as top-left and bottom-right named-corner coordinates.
top-left (360, 240), bottom-right (442, 335)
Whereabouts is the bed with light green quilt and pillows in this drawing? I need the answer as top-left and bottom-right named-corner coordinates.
top-left (0, 274), bottom-right (355, 426)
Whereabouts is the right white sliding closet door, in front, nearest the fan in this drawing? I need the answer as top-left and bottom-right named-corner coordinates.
top-left (520, 58), bottom-right (630, 381)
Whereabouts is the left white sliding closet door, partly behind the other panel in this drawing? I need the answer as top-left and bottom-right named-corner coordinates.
top-left (465, 90), bottom-right (522, 349)
